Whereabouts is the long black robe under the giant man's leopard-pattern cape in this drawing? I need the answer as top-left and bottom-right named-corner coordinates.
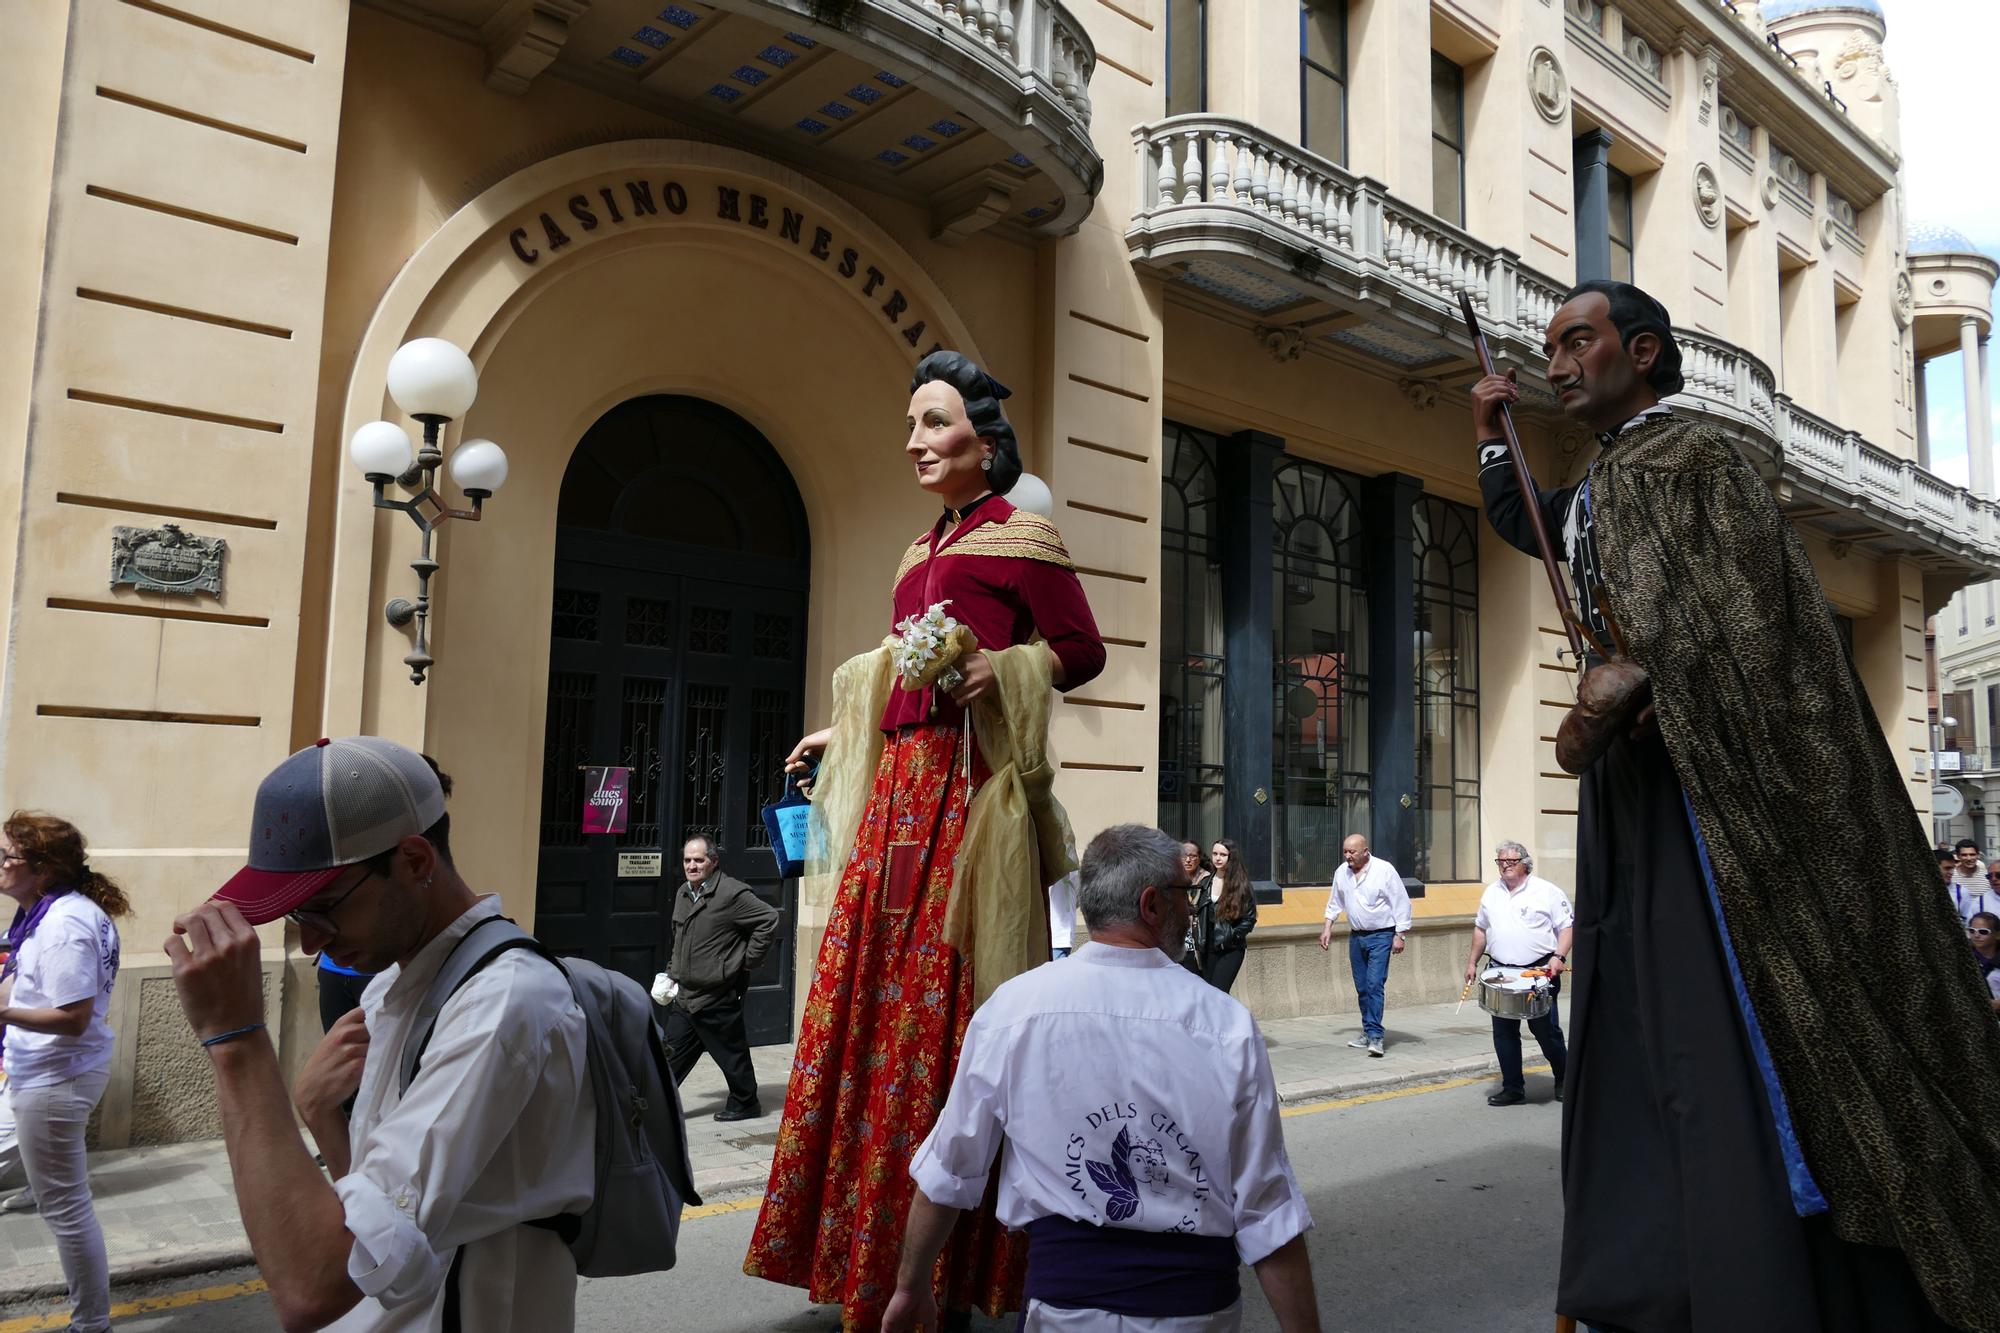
top-left (1480, 420), bottom-right (1974, 1333)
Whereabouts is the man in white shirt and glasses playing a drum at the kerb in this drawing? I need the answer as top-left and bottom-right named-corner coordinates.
top-left (1466, 843), bottom-right (1576, 1107)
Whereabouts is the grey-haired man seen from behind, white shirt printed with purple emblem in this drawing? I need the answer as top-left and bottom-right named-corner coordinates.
top-left (882, 825), bottom-right (1320, 1333)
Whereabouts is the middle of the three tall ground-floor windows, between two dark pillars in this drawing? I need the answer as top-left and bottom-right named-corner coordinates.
top-left (1272, 458), bottom-right (1370, 885)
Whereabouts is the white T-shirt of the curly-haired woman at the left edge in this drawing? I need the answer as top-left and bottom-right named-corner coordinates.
top-left (6, 889), bottom-right (118, 1087)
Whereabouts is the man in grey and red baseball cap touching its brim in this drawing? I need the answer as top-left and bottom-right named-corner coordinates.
top-left (166, 737), bottom-right (596, 1333)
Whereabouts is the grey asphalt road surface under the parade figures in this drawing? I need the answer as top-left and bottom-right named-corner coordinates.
top-left (0, 1075), bottom-right (1560, 1333)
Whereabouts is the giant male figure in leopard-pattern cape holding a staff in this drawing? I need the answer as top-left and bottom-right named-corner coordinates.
top-left (1472, 282), bottom-right (2000, 1333)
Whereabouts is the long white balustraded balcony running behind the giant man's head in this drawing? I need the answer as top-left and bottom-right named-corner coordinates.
top-left (1126, 114), bottom-right (2000, 584)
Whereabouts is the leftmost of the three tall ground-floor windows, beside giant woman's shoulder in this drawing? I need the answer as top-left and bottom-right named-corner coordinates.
top-left (1160, 422), bottom-right (1226, 847)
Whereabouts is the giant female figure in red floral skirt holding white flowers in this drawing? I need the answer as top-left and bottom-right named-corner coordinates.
top-left (744, 352), bottom-right (1104, 1329)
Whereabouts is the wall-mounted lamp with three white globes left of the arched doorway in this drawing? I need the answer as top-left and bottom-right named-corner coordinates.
top-left (348, 338), bottom-right (506, 685)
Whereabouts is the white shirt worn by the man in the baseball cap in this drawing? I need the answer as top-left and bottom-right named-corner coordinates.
top-left (332, 895), bottom-right (596, 1333)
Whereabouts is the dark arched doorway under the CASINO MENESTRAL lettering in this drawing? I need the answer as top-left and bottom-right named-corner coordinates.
top-left (534, 394), bottom-right (810, 1045)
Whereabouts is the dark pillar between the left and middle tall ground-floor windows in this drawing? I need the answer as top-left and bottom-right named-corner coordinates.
top-left (1216, 430), bottom-right (1284, 881)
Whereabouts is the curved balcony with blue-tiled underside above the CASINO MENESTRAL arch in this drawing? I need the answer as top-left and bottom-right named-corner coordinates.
top-left (378, 0), bottom-right (1104, 240)
